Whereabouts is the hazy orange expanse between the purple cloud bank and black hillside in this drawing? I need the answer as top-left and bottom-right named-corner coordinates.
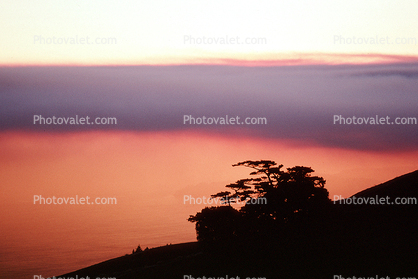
top-left (0, 132), bottom-right (418, 278)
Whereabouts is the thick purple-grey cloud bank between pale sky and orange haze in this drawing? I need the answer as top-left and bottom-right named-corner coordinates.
top-left (0, 63), bottom-right (418, 151)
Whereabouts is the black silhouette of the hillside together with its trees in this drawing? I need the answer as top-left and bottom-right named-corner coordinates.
top-left (56, 165), bottom-right (418, 279)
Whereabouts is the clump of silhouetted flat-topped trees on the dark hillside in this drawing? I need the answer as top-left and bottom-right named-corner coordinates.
top-left (188, 160), bottom-right (330, 242)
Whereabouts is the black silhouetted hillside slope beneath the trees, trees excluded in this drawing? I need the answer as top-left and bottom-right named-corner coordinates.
top-left (58, 171), bottom-right (418, 279)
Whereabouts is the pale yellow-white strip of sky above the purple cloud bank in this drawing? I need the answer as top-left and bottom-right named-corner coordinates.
top-left (0, 0), bottom-right (418, 65)
